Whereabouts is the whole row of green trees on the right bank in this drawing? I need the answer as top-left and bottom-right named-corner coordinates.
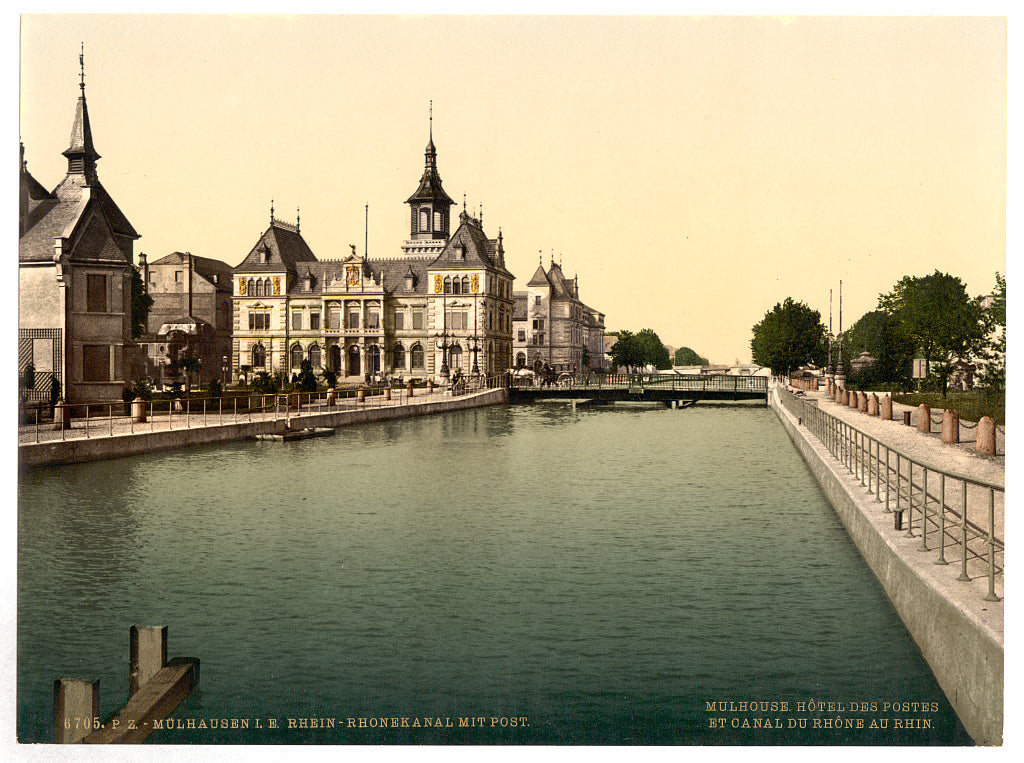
top-left (751, 270), bottom-right (1007, 394)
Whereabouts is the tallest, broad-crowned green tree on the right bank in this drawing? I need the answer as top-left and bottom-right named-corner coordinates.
top-left (879, 270), bottom-right (988, 396)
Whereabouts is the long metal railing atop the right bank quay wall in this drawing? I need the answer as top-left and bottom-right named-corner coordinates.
top-left (774, 386), bottom-right (1006, 601)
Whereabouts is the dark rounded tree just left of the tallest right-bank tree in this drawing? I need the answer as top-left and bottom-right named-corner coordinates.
top-left (833, 310), bottom-right (916, 388)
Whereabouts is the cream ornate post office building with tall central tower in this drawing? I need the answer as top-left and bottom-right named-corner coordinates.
top-left (231, 130), bottom-right (513, 381)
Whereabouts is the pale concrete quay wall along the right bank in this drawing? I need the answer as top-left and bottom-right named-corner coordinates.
top-left (769, 393), bottom-right (1004, 746)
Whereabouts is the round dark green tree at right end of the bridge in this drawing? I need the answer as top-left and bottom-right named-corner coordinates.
top-left (751, 297), bottom-right (828, 376)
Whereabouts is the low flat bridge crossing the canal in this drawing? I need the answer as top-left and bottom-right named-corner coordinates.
top-left (509, 374), bottom-right (768, 406)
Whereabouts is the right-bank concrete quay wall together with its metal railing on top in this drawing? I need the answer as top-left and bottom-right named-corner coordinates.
top-left (770, 386), bottom-right (1005, 745)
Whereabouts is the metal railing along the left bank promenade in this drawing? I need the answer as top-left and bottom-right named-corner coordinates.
top-left (18, 375), bottom-right (507, 443)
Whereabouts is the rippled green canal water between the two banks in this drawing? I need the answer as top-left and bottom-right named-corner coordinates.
top-left (17, 402), bottom-right (970, 745)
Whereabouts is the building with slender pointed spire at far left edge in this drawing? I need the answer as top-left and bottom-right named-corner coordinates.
top-left (18, 58), bottom-right (139, 402)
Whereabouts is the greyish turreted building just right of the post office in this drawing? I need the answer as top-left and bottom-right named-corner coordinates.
top-left (512, 260), bottom-right (605, 373)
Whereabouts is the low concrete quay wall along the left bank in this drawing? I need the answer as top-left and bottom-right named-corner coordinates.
top-left (17, 389), bottom-right (508, 467)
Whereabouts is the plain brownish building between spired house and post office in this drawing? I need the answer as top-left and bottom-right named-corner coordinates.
top-left (138, 252), bottom-right (231, 386)
